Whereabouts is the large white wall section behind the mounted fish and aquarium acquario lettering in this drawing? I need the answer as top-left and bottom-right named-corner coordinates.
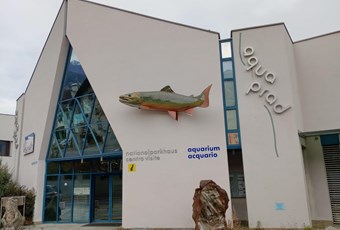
top-left (67, 1), bottom-right (231, 228)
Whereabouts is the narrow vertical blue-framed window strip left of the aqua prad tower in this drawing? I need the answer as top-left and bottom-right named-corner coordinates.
top-left (220, 39), bottom-right (241, 149)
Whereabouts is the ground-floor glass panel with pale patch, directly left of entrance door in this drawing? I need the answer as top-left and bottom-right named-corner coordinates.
top-left (73, 174), bottom-right (91, 223)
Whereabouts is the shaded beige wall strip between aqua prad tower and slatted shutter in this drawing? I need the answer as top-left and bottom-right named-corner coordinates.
top-left (304, 136), bottom-right (333, 221)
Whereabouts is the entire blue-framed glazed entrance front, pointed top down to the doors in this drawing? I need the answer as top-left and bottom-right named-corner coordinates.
top-left (43, 47), bottom-right (122, 223)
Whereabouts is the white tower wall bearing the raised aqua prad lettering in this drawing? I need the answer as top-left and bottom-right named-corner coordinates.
top-left (232, 24), bottom-right (311, 228)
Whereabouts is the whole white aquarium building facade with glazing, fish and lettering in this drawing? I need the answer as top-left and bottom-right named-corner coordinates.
top-left (0, 0), bottom-right (340, 228)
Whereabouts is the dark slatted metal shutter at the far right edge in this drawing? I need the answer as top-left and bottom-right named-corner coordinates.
top-left (322, 144), bottom-right (340, 224)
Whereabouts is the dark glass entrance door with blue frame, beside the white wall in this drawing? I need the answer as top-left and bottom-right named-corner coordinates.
top-left (92, 174), bottom-right (122, 222)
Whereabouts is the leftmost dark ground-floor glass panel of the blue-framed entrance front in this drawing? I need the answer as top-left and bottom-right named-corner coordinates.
top-left (44, 176), bottom-right (61, 222)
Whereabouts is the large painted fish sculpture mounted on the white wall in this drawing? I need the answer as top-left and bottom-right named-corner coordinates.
top-left (119, 85), bottom-right (212, 121)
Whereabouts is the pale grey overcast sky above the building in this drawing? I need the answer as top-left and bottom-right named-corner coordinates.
top-left (0, 0), bottom-right (340, 114)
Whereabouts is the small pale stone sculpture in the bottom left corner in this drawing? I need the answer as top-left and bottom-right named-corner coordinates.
top-left (1, 197), bottom-right (25, 230)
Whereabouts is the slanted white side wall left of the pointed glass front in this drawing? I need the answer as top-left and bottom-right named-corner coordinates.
top-left (17, 1), bottom-right (68, 221)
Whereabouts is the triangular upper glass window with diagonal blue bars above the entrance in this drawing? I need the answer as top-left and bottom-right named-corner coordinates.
top-left (48, 45), bottom-right (120, 159)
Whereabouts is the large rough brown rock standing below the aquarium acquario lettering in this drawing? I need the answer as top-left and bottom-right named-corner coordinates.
top-left (192, 180), bottom-right (229, 230)
